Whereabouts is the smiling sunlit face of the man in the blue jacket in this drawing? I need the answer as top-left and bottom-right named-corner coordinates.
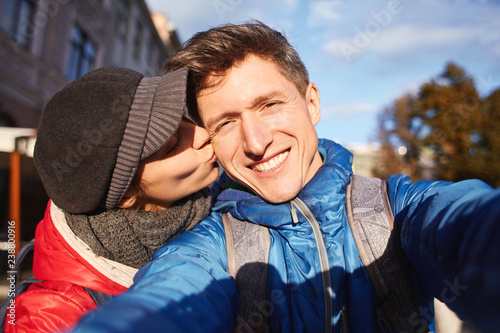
top-left (197, 55), bottom-right (322, 203)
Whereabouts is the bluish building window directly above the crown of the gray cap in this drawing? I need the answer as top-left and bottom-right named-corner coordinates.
top-left (66, 25), bottom-right (95, 81)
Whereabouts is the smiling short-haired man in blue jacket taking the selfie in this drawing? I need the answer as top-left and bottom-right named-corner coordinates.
top-left (73, 22), bottom-right (500, 332)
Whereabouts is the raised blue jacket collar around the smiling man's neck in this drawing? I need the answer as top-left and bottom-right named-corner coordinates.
top-left (214, 139), bottom-right (352, 227)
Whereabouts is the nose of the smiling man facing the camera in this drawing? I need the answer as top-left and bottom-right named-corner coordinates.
top-left (241, 114), bottom-right (273, 157)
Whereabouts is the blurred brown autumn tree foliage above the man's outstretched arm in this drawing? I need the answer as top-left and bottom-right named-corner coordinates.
top-left (374, 63), bottom-right (500, 187)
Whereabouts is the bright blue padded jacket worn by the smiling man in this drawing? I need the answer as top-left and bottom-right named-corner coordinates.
top-left (75, 140), bottom-right (500, 333)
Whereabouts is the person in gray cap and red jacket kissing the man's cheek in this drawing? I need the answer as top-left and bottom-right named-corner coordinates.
top-left (6, 68), bottom-right (218, 332)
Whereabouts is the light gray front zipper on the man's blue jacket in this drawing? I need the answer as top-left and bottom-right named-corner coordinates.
top-left (290, 198), bottom-right (333, 333)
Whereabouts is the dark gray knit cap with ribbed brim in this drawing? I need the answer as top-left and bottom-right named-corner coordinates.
top-left (34, 68), bottom-right (187, 214)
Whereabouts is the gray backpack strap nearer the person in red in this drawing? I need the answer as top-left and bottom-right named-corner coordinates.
top-left (222, 213), bottom-right (271, 332)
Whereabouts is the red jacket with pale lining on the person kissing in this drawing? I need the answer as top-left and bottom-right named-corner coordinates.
top-left (5, 201), bottom-right (137, 333)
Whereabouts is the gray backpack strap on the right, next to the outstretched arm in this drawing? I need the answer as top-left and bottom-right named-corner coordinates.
top-left (346, 175), bottom-right (430, 333)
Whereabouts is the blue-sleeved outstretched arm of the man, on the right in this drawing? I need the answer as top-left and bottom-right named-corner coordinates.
top-left (388, 176), bottom-right (500, 331)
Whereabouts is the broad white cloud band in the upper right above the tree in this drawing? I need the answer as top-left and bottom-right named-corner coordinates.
top-left (323, 0), bottom-right (500, 61)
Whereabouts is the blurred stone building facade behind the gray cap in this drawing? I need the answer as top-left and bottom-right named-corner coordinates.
top-left (0, 0), bottom-right (178, 128)
